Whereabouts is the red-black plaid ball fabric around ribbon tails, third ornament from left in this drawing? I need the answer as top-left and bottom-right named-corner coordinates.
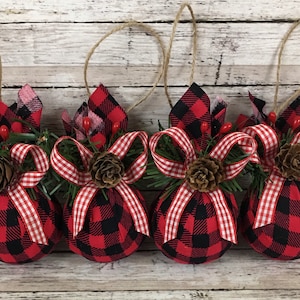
top-left (151, 191), bottom-right (238, 264)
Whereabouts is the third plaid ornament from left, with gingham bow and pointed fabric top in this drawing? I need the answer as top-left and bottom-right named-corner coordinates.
top-left (149, 83), bottom-right (256, 264)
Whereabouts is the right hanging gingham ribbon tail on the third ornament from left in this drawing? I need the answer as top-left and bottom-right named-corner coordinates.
top-left (207, 189), bottom-right (237, 244)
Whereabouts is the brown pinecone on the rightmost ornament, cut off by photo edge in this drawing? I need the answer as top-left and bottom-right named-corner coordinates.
top-left (275, 144), bottom-right (300, 180)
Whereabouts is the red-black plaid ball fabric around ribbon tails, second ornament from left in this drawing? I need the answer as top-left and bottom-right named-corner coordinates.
top-left (63, 188), bottom-right (146, 262)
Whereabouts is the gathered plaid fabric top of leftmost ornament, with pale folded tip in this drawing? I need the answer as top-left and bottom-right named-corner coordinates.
top-left (0, 84), bottom-right (43, 132)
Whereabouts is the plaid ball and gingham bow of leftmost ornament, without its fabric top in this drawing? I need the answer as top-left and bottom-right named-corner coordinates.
top-left (0, 144), bottom-right (62, 264)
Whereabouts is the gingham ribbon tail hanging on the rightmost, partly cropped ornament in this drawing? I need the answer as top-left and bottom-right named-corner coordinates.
top-left (253, 171), bottom-right (285, 229)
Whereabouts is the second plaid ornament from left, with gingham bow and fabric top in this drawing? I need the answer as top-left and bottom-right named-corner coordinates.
top-left (51, 85), bottom-right (149, 262)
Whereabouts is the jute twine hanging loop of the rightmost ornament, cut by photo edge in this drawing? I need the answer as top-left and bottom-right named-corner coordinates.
top-left (273, 20), bottom-right (300, 115)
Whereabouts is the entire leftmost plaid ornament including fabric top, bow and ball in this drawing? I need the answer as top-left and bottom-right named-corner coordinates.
top-left (0, 85), bottom-right (62, 264)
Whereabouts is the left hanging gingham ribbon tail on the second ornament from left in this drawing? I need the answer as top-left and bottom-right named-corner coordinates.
top-left (73, 182), bottom-right (99, 238)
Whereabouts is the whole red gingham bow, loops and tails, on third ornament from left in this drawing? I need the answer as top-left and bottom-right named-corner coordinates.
top-left (149, 127), bottom-right (257, 243)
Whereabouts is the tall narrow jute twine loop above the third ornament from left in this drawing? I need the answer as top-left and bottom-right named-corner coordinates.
top-left (164, 3), bottom-right (197, 108)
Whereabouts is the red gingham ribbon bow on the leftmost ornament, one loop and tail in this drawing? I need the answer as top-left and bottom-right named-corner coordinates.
top-left (7, 144), bottom-right (49, 245)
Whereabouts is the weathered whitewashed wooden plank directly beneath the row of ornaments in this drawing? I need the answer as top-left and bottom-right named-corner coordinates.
top-left (0, 250), bottom-right (300, 292)
